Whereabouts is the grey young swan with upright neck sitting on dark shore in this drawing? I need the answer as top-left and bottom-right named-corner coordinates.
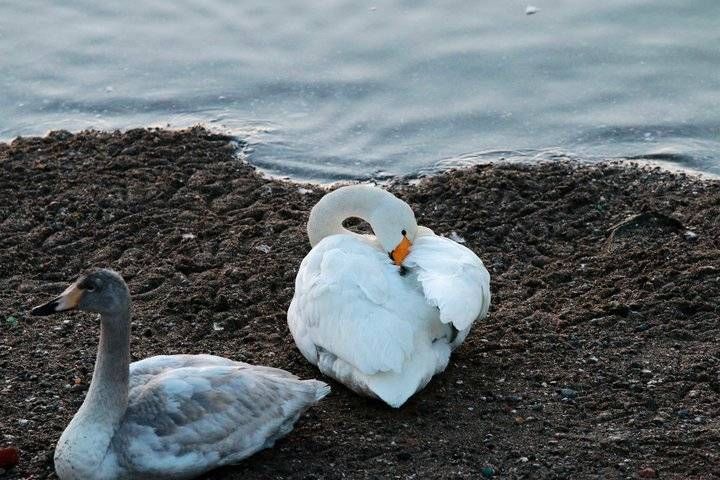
top-left (32, 269), bottom-right (330, 480)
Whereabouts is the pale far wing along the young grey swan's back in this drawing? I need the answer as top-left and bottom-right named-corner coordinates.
top-left (130, 354), bottom-right (297, 392)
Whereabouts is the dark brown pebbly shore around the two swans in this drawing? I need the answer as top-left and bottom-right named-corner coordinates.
top-left (0, 128), bottom-right (720, 479)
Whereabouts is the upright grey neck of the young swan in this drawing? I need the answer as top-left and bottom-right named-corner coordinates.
top-left (55, 305), bottom-right (130, 472)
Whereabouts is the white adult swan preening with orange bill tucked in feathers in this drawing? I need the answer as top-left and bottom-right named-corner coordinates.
top-left (288, 185), bottom-right (490, 407)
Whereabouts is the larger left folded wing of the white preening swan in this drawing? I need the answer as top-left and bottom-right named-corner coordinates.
top-left (288, 235), bottom-right (413, 375)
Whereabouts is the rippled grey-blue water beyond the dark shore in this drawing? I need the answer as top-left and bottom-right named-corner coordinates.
top-left (0, 0), bottom-right (720, 181)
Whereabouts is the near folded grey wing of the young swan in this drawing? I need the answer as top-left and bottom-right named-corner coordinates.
top-left (113, 365), bottom-right (330, 478)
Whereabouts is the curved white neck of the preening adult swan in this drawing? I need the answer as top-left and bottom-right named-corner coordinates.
top-left (307, 185), bottom-right (393, 247)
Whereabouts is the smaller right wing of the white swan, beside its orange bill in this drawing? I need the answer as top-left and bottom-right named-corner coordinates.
top-left (404, 234), bottom-right (490, 331)
